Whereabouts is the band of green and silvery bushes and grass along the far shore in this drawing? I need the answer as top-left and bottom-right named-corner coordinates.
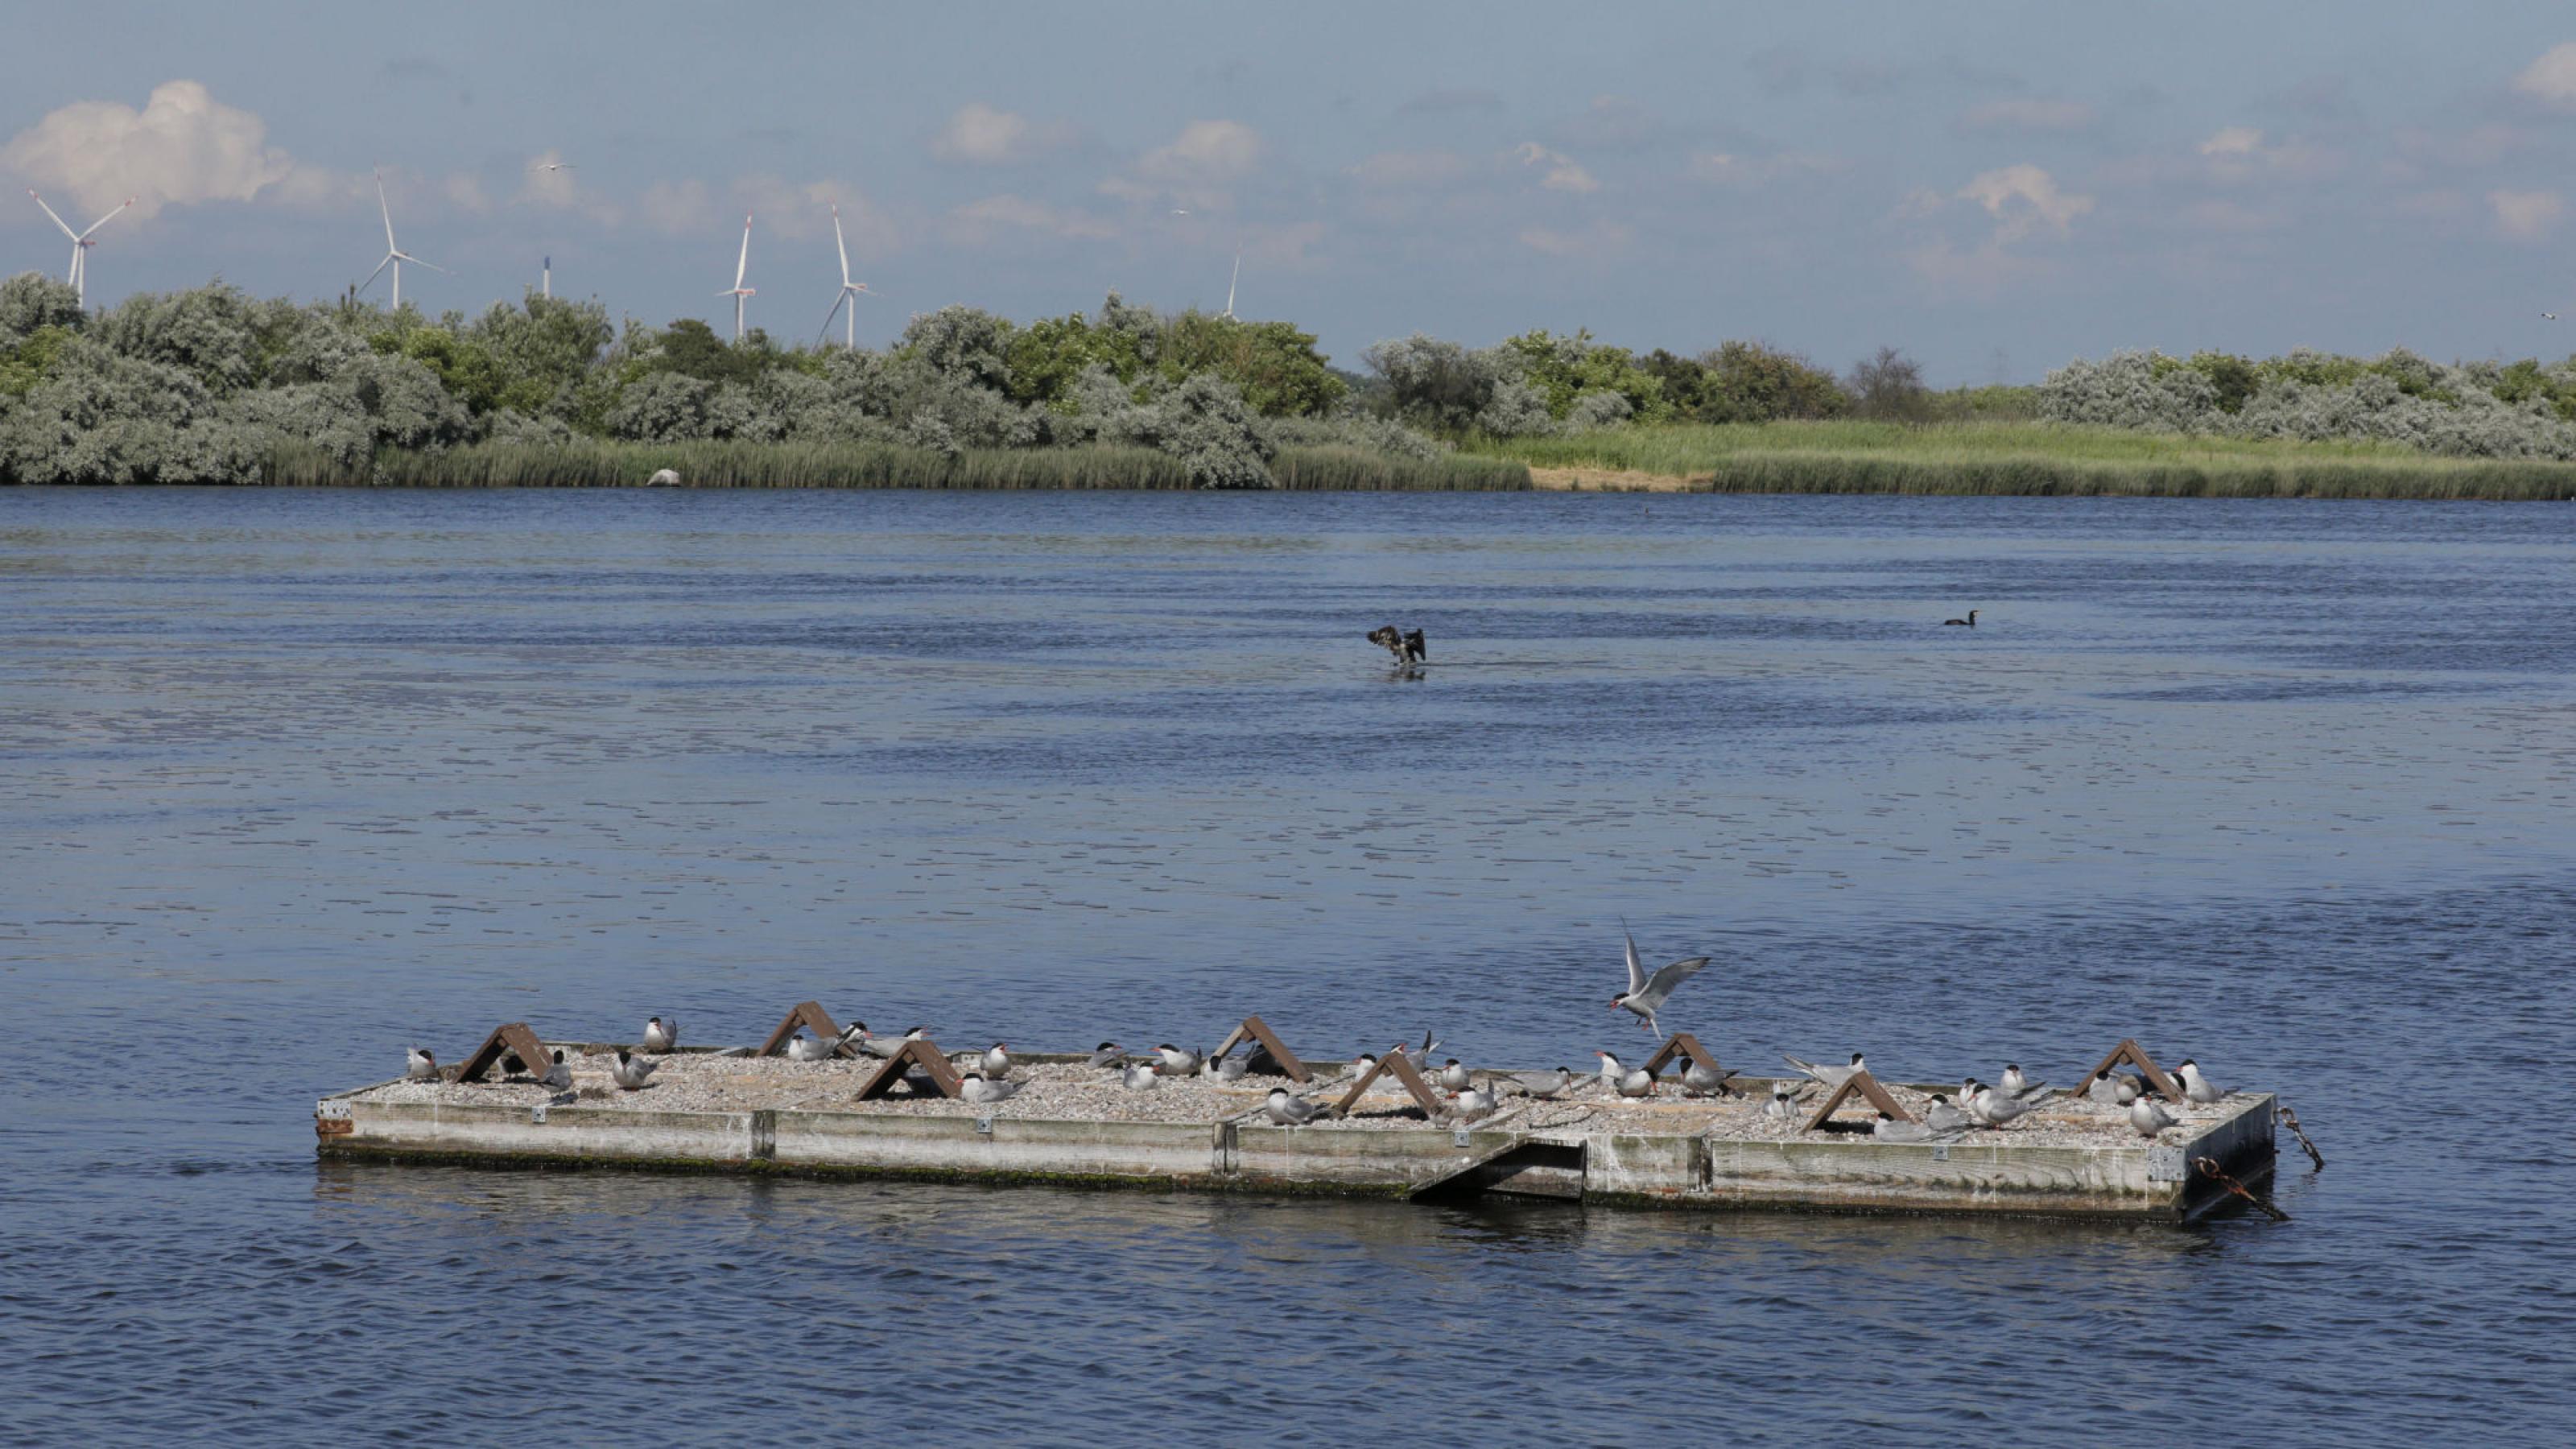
top-left (14, 274), bottom-right (2576, 497)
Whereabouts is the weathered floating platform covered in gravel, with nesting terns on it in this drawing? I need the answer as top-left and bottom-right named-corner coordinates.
top-left (314, 1042), bottom-right (2275, 1222)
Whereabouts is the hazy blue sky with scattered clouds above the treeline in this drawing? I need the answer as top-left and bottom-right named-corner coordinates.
top-left (0, 0), bottom-right (2576, 382)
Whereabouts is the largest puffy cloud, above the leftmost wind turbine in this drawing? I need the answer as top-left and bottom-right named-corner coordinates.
top-left (0, 80), bottom-right (345, 217)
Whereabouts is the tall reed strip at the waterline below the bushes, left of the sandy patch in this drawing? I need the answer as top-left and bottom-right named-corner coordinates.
top-left (262, 438), bottom-right (1530, 493)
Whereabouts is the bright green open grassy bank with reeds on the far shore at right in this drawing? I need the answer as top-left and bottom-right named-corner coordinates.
top-left (1466, 423), bottom-right (2576, 500)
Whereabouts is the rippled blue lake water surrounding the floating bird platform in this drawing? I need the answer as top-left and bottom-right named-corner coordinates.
top-left (0, 490), bottom-right (2576, 1444)
